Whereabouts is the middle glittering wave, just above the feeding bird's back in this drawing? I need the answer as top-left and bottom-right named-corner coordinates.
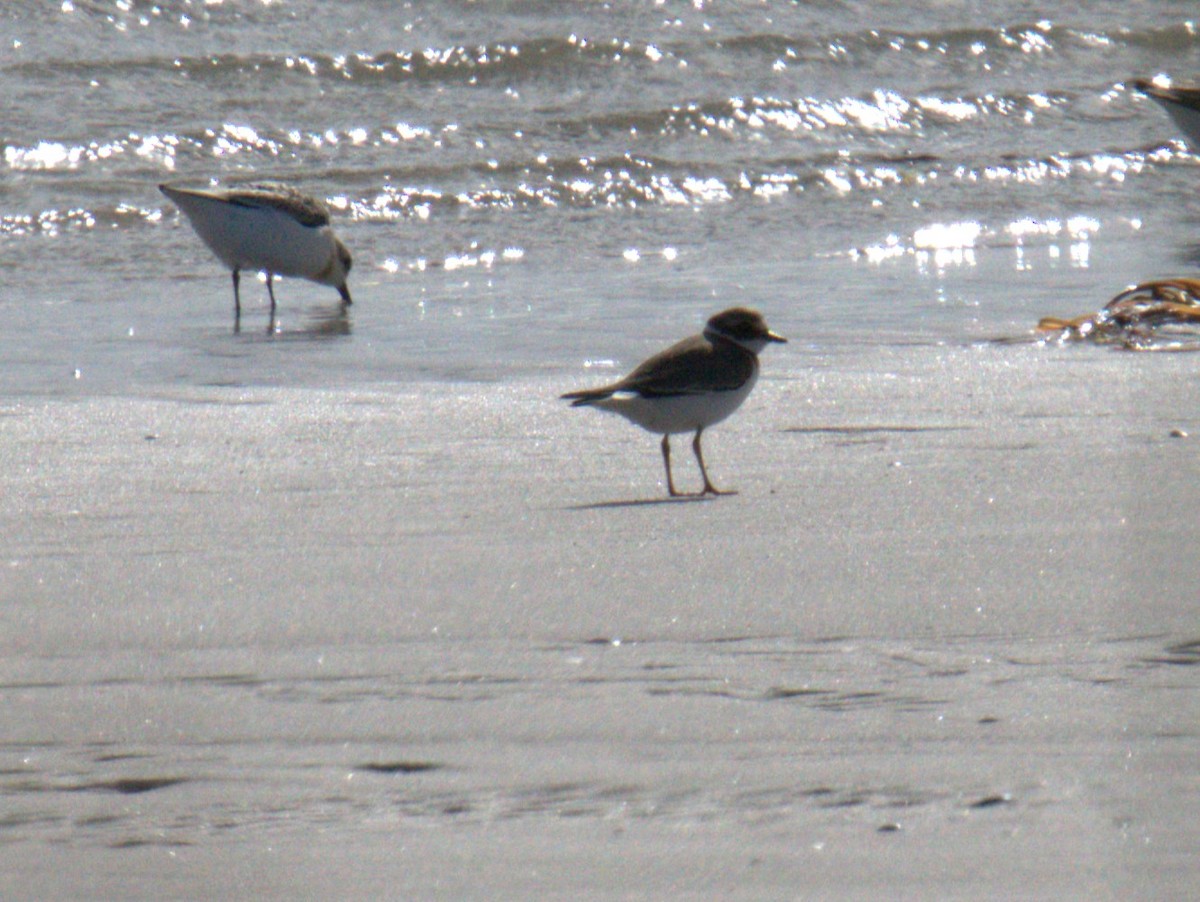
top-left (0, 81), bottom-right (1104, 184)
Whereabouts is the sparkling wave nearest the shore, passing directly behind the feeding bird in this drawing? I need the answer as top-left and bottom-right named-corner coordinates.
top-left (0, 139), bottom-right (1180, 236)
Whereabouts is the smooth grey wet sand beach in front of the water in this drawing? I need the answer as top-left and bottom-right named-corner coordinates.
top-left (0, 343), bottom-right (1200, 898)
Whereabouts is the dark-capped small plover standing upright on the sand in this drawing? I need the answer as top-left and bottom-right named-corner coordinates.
top-left (563, 307), bottom-right (787, 497)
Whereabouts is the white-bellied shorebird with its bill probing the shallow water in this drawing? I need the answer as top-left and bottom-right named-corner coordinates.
top-left (158, 182), bottom-right (350, 319)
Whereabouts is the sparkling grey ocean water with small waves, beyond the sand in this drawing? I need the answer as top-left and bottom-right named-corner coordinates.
top-left (7, 0), bottom-right (1200, 395)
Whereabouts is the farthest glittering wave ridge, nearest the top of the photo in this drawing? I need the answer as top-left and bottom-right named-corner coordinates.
top-left (4, 20), bottom-right (1200, 84)
